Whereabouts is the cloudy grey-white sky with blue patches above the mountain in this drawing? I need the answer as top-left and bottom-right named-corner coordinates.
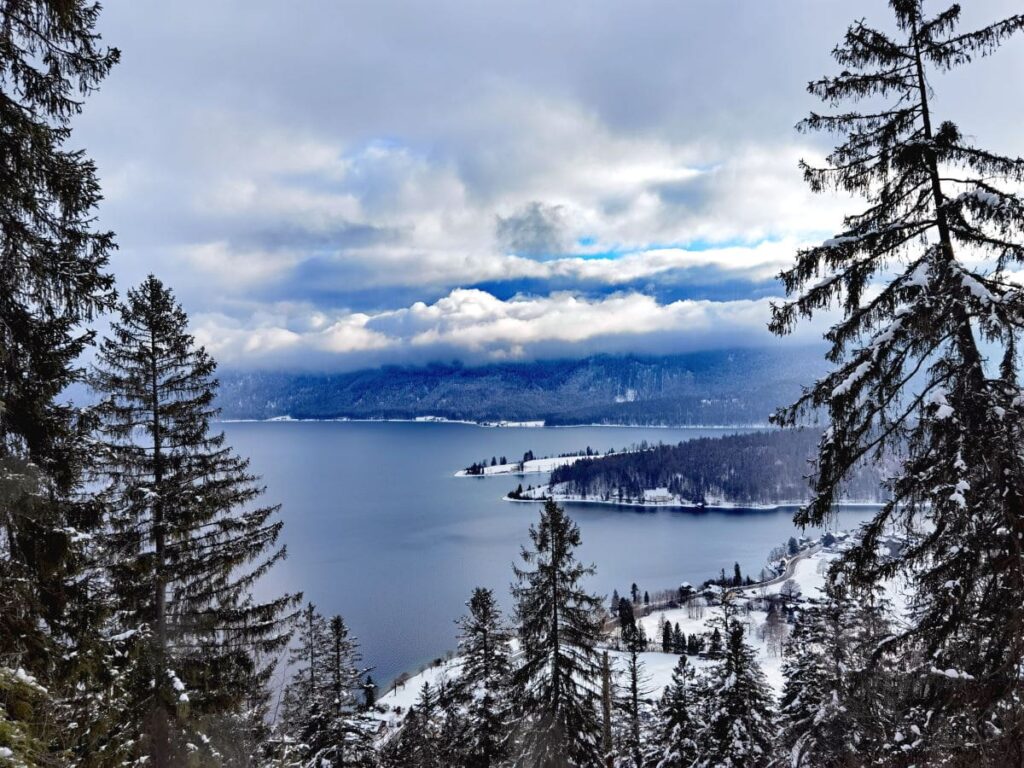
top-left (72, 0), bottom-right (1024, 370)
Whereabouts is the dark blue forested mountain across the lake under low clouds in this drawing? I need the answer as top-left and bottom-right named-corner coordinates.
top-left (218, 348), bottom-right (824, 425)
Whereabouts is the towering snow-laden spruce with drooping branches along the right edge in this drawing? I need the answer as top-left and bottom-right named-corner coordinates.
top-left (772, 0), bottom-right (1024, 764)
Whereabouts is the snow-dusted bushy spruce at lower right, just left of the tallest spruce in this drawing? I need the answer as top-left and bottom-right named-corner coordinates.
top-left (777, 584), bottom-right (900, 768)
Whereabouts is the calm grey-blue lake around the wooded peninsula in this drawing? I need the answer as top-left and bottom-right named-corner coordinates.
top-left (221, 422), bottom-right (868, 684)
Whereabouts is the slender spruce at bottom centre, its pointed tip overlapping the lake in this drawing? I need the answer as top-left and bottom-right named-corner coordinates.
top-left (512, 499), bottom-right (602, 768)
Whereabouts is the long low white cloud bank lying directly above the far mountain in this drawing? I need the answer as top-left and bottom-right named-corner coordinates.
top-left (194, 289), bottom-right (808, 370)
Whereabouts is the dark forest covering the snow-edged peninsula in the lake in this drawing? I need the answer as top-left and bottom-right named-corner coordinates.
top-left (550, 429), bottom-right (886, 504)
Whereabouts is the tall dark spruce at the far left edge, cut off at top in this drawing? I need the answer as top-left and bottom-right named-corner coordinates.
top-left (0, 0), bottom-right (118, 764)
